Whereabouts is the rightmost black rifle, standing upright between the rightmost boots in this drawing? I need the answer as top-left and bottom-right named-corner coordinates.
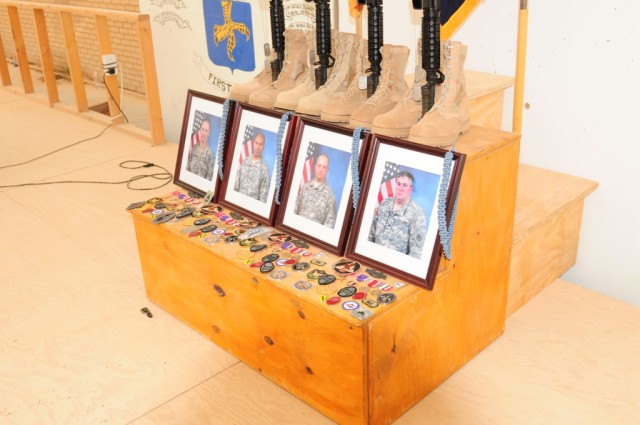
top-left (413, 0), bottom-right (445, 115)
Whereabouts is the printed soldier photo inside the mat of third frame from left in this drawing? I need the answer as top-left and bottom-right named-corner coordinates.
top-left (293, 142), bottom-right (350, 229)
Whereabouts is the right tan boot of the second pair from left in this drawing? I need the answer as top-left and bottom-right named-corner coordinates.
top-left (296, 31), bottom-right (357, 115)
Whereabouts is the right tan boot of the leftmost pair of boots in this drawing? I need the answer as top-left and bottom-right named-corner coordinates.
top-left (249, 29), bottom-right (309, 108)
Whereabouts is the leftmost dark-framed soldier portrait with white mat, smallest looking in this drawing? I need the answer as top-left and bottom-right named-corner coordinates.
top-left (173, 90), bottom-right (235, 201)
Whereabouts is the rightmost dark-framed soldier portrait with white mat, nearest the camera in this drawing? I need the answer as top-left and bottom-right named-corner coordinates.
top-left (346, 134), bottom-right (466, 289)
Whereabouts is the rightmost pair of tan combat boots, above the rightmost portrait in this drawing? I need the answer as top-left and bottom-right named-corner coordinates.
top-left (371, 40), bottom-right (471, 147)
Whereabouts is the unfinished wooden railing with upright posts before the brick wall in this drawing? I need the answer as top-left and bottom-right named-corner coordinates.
top-left (0, 0), bottom-right (165, 144)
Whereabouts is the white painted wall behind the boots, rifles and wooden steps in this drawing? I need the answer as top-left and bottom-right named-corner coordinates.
top-left (140, 0), bottom-right (640, 306)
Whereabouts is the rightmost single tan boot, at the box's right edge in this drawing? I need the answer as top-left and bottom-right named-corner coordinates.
top-left (409, 41), bottom-right (471, 147)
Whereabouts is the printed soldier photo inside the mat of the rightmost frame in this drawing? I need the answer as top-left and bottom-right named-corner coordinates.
top-left (368, 165), bottom-right (438, 259)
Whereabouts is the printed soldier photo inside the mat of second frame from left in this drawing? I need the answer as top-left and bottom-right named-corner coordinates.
top-left (232, 125), bottom-right (277, 203)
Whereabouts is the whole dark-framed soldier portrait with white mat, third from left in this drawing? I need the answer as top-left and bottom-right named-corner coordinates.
top-left (276, 117), bottom-right (369, 255)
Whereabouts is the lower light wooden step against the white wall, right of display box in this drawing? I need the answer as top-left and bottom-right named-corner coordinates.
top-left (507, 164), bottom-right (598, 315)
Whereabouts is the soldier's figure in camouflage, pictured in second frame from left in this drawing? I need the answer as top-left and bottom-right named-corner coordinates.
top-left (233, 133), bottom-right (269, 202)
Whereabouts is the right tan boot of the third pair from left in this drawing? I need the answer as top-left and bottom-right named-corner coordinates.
top-left (349, 44), bottom-right (409, 128)
